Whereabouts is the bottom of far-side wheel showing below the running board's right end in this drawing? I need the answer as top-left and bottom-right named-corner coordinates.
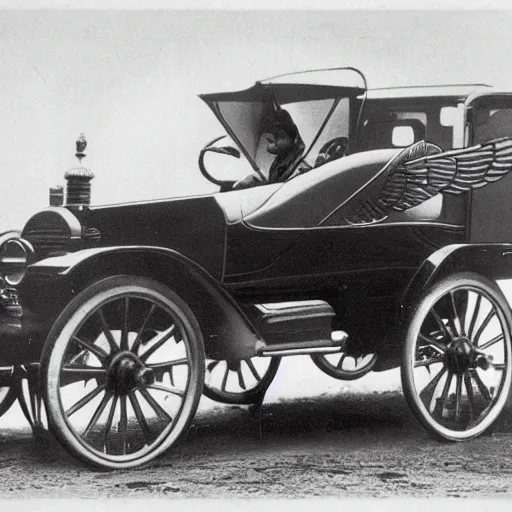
top-left (311, 352), bottom-right (377, 380)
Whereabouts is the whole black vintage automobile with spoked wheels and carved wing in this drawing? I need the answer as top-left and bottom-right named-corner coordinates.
top-left (0, 68), bottom-right (512, 469)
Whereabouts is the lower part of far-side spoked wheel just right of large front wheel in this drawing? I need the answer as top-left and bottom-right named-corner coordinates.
top-left (203, 357), bottom-right (281, 404)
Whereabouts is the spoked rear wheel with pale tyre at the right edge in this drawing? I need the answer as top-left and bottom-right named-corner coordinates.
top-left (401, 272), bottom-right (512, 441)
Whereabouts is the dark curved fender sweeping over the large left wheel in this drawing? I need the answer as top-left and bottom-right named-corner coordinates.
top-left (27, 246), bottom-right (263, 359)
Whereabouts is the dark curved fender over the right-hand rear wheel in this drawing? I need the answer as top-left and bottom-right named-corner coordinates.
top-left (401, 244), bottom-right (512, 318)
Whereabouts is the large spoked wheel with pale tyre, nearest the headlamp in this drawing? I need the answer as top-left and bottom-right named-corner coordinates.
top-left (41, 276), bottom-right (205, 469)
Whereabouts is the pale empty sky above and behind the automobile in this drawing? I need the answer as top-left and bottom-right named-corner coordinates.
top-left (0, 10), bottom-right (512, 230)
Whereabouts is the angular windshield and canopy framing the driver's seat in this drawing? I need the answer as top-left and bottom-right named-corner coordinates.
top-left (200, 68), bottom-right (366, 177)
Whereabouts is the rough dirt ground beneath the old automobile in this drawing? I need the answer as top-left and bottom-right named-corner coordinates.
top-left (0, 360), bottom-right (512, 499)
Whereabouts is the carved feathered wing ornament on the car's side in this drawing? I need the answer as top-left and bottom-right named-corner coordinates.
top-left (345, 137), bottom-right (512, 224)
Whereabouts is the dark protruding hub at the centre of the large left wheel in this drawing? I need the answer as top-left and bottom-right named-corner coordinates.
top-left (107, 352), bottom-right (155, 395)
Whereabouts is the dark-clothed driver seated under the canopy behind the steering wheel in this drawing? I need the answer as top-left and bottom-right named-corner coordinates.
top-left (233, 108), bottom-right (309, 190)
